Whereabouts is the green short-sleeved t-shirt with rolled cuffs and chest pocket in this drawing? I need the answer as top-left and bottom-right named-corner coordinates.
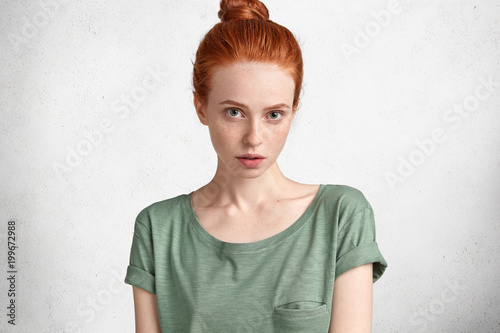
top-left (125, 184), bottom-right (387, 333)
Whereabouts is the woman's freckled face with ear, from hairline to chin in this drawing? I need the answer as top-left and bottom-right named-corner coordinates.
top-left (195, 62), bottom-right (295, 178)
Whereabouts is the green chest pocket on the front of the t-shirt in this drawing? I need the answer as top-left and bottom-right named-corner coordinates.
top-left (273, 301), bottom-right (330, 333)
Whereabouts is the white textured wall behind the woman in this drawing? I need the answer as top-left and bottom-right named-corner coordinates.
top-left (0, 0), bottom-right (500, 332)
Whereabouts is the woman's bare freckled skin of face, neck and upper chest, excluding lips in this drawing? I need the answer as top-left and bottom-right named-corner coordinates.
top-left (192, 62), bottom-right (319, 243)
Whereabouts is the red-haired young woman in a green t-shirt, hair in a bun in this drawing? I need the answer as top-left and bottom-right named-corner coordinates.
top-left (125, 0), bottom-right (387, 333)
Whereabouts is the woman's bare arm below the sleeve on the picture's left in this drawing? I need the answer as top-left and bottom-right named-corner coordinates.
top-left (132, 286), bottom-right (161, 333)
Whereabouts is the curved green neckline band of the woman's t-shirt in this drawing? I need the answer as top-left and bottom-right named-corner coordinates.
top-left (184, 184), bottom-right (326, 253)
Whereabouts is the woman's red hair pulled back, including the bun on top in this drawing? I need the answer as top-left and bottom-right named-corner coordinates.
top-left (193, 0), bottom-right (303, 108)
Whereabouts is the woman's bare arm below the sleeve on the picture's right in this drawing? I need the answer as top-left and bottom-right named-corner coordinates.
top-left (328, 263), bottom-right (373, 333)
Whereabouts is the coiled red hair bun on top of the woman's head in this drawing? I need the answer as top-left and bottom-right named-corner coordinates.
top-left (219, 0), bottom-right (269, 22)
